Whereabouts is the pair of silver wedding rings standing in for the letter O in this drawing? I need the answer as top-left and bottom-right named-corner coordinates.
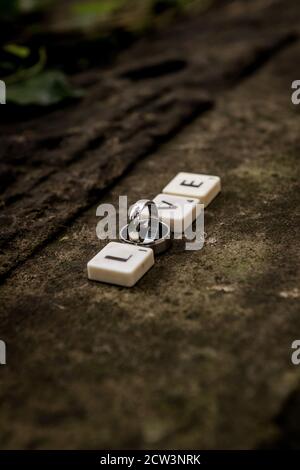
top-left (120, 199), bottom-right (171, 254)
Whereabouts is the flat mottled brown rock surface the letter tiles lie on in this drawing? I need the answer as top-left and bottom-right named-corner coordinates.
top-left (0, 2), bottom-right (300, 448)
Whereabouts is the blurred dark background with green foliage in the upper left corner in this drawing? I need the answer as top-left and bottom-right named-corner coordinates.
top-left (0, 0), bottom-right (218, 107)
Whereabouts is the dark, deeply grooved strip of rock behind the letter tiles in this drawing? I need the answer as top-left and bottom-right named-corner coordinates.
top-left (0, 1), bottom-right (298, 279)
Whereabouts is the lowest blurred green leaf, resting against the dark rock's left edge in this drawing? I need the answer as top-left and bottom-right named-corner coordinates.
top-left (7, 70), bottom-right (83, 106)
